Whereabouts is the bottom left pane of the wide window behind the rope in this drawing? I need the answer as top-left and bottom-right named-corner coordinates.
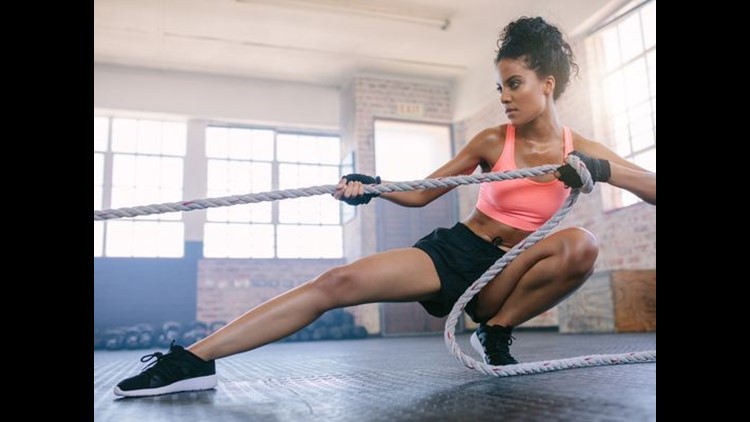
top-left (203, 223), bottom-right (274, 258)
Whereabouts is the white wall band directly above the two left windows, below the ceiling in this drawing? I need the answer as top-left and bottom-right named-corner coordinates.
top-left (94, 63), bottom-right (340, 130)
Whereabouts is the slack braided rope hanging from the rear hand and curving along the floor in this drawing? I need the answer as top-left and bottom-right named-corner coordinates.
top-left (444, 155), bottom-right (656, 377)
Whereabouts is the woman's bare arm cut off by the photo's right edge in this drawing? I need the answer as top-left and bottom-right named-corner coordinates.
top-left (575, 137), bottom-right (656, 205)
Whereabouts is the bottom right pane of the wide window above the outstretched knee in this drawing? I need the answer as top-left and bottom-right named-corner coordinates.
top-left (278, 225), bottom-right (343, 258)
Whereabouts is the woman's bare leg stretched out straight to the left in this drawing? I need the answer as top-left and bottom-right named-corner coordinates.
top-left (188, 248), bottom-right (440, 360)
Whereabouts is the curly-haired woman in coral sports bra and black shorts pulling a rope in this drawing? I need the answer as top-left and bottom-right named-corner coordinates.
top-left (115, 17), bottom-right (656, 396)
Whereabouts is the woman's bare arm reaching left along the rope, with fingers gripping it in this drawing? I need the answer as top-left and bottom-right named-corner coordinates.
top-left (334, 129), bottom-right (500, 207)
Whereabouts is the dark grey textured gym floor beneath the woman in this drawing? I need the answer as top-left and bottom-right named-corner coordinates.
top-left (94, 331), bottom-right (656, 422)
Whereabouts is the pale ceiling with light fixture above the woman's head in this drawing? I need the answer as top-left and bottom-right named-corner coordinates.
top-left (94, 0), bottom-right (623, 86)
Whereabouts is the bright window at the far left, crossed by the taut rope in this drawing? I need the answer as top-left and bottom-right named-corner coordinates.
top-left (94, 116), bottom-right (186, 257)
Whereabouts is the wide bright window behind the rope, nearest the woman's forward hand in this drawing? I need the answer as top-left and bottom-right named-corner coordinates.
top-left (203, 126), bottom-right (343, 258)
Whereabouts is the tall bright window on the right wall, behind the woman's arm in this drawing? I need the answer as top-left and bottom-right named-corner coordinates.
top-left (589, 1), bottom-right (656, 209)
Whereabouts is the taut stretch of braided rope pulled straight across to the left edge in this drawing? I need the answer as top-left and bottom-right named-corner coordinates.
top-left (94, 164), bottom-right (560, 221)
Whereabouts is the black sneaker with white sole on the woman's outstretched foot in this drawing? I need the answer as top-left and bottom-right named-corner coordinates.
top-left (114, 343), bottom-right (216, 397)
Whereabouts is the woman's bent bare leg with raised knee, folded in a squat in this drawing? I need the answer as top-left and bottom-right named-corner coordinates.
top-left (476, 228), bottom-right (599, 327)
